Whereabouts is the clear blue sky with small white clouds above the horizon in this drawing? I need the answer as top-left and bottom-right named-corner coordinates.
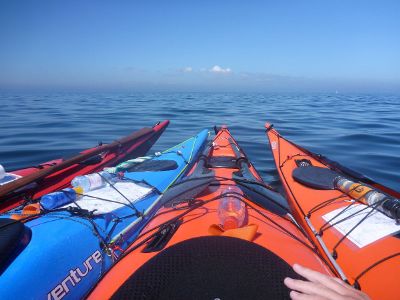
top-left (0, 0), bottom-right (400, 91)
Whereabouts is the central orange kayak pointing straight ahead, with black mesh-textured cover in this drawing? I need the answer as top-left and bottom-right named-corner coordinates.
top-left (88, 126), bottom-right (334, 299)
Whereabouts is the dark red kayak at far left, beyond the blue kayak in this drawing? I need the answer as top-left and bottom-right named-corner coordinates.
top-left (0, 120), bottom-right (169, 213)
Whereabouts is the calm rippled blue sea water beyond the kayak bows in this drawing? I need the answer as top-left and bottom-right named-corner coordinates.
top-left (0, 93), bottom-right (400, 190)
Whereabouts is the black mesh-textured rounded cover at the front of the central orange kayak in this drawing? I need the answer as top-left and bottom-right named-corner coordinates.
top-left (112, 236), bottom-right (298, 300)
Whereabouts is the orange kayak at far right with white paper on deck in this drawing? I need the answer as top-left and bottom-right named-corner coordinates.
top-left (266, 123), bottom-right (400, 299)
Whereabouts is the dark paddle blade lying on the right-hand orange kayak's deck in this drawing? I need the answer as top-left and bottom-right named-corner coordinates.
top-left (292, 166), bottom-right (340, 190)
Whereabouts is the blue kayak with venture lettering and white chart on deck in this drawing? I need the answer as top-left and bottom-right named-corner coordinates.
top-left (0, 130), bottom-right (208, 299)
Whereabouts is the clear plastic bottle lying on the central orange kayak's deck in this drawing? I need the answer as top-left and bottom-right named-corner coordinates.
top-left (218, 185), bottom-right (246, 230)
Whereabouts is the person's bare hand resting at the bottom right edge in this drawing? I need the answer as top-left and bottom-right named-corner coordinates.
top-left (284, 264), bottom-right (370, 300)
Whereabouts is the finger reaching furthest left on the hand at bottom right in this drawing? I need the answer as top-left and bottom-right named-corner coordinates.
top-left (283, 277), bottom-right (342, 299)
